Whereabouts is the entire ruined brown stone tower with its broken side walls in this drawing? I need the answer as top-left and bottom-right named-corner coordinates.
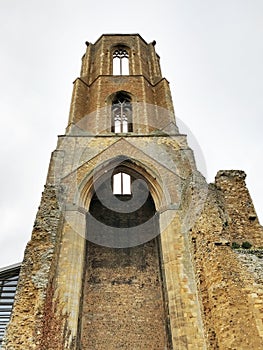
top-left (3, 34), bottom-right (263, 350)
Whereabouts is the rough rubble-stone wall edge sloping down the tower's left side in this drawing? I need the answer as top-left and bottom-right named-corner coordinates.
top-left (3, 184), bottom-right (61, 350)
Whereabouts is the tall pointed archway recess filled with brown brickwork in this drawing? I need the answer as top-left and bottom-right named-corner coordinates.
top-left (81, 161), bottom-right (169, 350)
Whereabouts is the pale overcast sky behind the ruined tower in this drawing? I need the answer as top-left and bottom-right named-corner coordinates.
top-left (0, 0), bottom-right (263, 267)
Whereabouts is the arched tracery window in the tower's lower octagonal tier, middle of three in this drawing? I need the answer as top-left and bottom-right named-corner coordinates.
top-left (112, 93), bottom-right (132, 133)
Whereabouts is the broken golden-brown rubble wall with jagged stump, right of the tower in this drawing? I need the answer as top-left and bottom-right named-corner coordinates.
top-left (190, 171), bottom-right (263, 350)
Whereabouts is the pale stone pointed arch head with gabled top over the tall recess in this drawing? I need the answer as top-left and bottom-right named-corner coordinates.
top-left (61, 136), bottom-right (189, 217)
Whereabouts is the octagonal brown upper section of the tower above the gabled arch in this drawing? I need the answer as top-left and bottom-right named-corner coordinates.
top-left (67, 34), bottom-right (177, 135)
